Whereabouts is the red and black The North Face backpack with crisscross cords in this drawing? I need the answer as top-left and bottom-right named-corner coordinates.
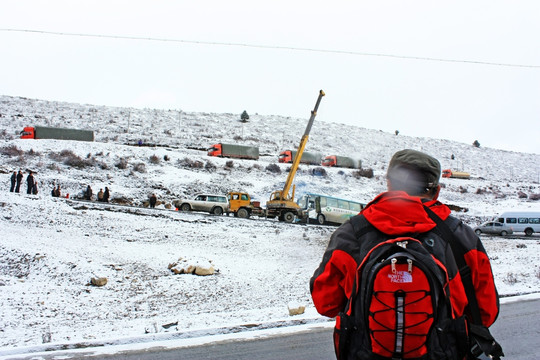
top-left (334, 215), bottom-right (468, 360)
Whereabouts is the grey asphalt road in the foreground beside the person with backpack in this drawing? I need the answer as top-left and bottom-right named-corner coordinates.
top-left (0, 299), bottom-right (540, 360)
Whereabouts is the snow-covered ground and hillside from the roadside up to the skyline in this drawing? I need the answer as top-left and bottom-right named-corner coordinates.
top-left (0, 97), bottom-right (540, 348)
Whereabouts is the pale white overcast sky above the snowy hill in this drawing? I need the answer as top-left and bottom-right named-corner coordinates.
top-left (0, 0), bottom-right (540, 154)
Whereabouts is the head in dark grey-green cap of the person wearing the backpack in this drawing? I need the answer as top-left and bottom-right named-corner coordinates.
top-left (387, 149), bottom-right (441, 195)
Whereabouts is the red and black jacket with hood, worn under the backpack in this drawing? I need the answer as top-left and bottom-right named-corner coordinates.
top-left (310, 191), bottom-right (499, 326)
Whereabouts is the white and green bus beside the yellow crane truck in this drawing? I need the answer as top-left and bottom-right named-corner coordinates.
top-left (298, 193), bottom-right (366, 225)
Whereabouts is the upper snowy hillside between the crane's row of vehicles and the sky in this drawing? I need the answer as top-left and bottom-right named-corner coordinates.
top-left (0, 96), bottom-right (540, 215)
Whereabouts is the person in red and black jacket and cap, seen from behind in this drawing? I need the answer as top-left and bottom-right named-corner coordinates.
top-left (310, 149), bottom-right (503, 360)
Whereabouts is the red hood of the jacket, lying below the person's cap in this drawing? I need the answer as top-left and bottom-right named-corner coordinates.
top-left (361, 191), bottom-right (450, 235)
